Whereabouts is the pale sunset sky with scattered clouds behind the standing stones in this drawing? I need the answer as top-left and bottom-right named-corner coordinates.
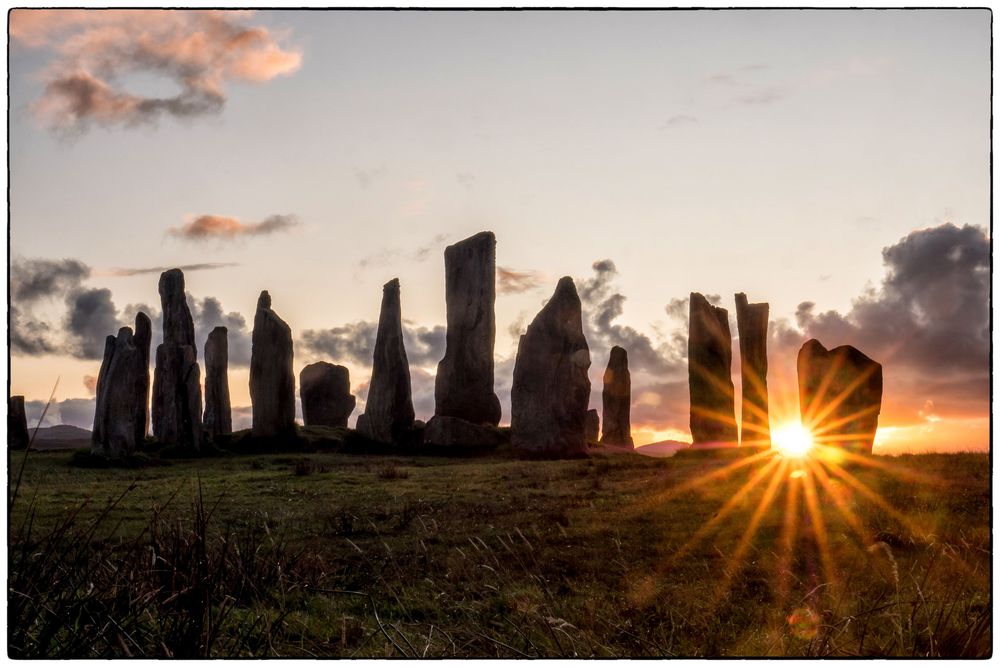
top-left (8, 10), bottom-right (991, 453)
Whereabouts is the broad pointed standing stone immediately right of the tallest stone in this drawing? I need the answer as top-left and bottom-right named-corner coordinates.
top-left (510, 277), bottom-right (590, 457)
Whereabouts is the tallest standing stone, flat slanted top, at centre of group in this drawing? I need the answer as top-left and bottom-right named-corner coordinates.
top-left (434, 232), bottom-right (500, 426)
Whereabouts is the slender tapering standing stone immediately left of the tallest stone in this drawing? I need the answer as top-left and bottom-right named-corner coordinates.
top-left (358, 278), bottom-right (413, 442)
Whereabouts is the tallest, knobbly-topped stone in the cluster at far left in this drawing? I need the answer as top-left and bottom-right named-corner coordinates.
top-left (153, 269), bottom-right (203, 451)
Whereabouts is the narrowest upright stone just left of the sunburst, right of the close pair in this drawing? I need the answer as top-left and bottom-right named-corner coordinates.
top-left (736, 292), bottom-right (771, 446)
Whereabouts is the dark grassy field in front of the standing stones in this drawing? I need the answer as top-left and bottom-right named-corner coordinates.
top-left (8, 438), bottom-right (992, 657)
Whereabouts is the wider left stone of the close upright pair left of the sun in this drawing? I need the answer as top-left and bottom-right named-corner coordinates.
top-left (688, 292), bottom-right (738, 446)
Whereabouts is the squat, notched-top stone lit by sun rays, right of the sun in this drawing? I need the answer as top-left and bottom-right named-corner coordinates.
top-left (797, 339), bottom-right (882, 454)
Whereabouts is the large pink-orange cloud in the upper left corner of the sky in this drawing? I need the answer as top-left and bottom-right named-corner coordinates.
top-left (9, 9), bottom-right (302, 134)
